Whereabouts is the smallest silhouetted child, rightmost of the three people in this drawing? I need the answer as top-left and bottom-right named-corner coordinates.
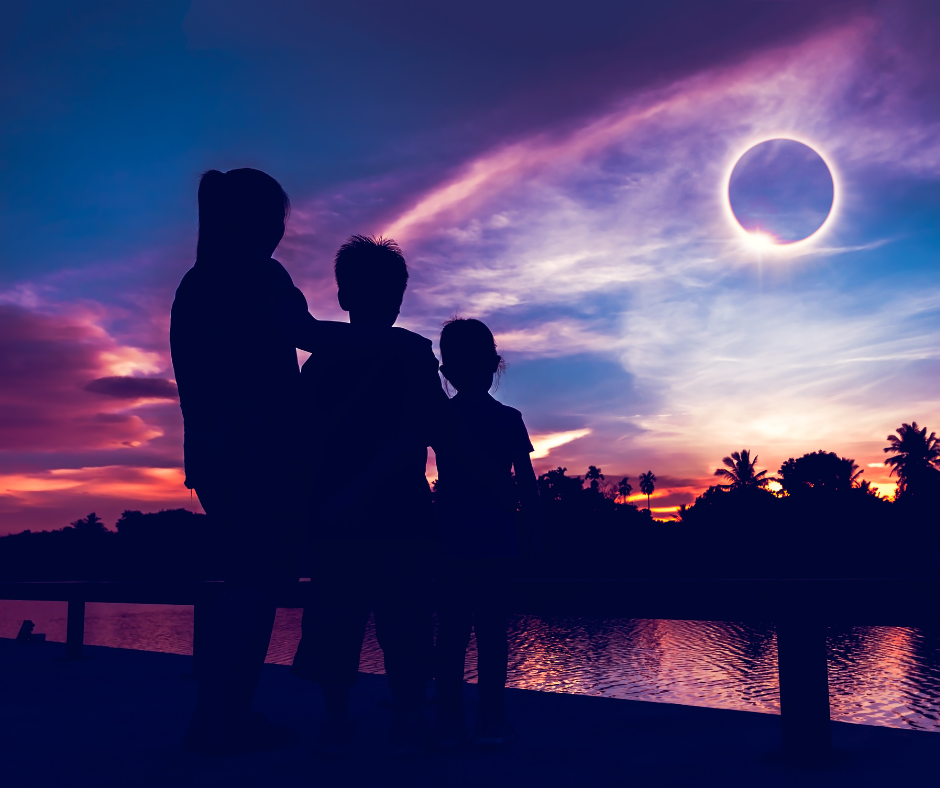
top-left (434, 318), bottom-right (538, 746)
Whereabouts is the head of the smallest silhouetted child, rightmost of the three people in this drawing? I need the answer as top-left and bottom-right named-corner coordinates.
top-left (441, 317), bottom-right (506, 393)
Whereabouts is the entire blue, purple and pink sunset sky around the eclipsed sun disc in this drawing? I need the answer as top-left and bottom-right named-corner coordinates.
top-left (0, 0), bottom-right (940, 533)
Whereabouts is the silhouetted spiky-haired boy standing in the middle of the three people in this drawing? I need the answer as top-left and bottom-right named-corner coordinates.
top-left (293, 236), bottom-right (447, 754)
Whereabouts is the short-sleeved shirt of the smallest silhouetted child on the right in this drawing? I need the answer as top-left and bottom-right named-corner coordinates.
top-left (434, 392), bottom-right (532, 558)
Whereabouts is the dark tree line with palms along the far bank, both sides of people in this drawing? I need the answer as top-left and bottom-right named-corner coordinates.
top-left (0, 422), bottom-right (940, 580)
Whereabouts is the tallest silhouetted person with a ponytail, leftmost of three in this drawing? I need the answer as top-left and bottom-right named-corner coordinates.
top-left (170, 168), bottom-right (326, 753)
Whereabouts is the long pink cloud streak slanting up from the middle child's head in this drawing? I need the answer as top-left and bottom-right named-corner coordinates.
top-left (383, 18), bottom-right (888, 248)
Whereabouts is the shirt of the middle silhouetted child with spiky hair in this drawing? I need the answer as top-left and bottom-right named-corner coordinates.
top-left (301, 324), bottom-right (447, 539)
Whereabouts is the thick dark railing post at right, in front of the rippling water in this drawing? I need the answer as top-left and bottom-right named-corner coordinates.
top-left (776, 619), bottom-right (832, 765)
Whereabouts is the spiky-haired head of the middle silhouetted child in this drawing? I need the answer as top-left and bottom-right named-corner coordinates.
top-left (334, 235), bottom-right (408, 326)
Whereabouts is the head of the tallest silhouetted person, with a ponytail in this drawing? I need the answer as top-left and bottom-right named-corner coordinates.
top-left (196, 167), bottom-right (290, 263)
